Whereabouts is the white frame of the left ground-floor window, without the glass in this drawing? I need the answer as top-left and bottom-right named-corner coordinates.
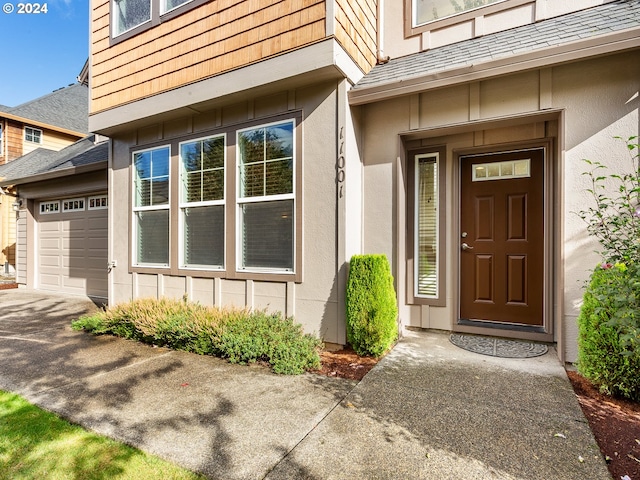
top-left (129, 142), bottom-right (174, 271)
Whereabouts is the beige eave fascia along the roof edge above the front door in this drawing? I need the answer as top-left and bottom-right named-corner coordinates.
top-left (349, 27), bottom-right (640, 105)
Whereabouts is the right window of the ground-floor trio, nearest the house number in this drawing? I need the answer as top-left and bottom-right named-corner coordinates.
top-left (237, 121), bottom-right (295, 271)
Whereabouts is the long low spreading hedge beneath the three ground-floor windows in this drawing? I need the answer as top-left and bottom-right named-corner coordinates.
top-left (71, 298), bottom-right (322, 374)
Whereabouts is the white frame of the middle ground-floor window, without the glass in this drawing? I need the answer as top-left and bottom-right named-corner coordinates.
top-left (179, 132), bottom-right (229, 272)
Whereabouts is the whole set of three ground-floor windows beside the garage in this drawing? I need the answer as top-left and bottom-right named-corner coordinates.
top-left (131, 114), bottom-right (302, 281)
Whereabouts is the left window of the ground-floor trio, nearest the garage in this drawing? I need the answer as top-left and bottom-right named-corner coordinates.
top-left (133, 146), bottom-right (170, 266)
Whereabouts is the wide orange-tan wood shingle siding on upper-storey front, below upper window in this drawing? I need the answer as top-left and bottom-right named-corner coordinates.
top-left (90, 0), bottom-right (328, 114)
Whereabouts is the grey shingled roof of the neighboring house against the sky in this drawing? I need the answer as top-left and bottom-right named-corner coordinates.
top-left (0, 83), bottom-right (89, 134)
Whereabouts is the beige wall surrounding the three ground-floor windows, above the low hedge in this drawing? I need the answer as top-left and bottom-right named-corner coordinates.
top-left (109, 82), bottom-right (344, 343)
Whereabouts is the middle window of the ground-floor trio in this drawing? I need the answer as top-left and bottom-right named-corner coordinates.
top-left (180, 135), bottom-right (225, 268)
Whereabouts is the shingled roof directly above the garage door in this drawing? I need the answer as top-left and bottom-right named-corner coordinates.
top-left (0, 135), bottom-right (109, 186)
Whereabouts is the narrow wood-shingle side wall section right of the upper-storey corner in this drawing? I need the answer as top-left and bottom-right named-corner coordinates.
top-left (335, 0), bottom-right (377, 73)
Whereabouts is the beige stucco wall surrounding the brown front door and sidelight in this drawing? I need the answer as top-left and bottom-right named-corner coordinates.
top-left (362, 52), bottom-right (640, 361)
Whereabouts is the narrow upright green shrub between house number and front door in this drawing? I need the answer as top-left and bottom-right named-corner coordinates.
top-left (346, 255), bottom-right (398, 357)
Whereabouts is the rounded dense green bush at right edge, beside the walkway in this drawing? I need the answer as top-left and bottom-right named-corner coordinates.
top-left (577, 263), bottom-right (640, 401)
